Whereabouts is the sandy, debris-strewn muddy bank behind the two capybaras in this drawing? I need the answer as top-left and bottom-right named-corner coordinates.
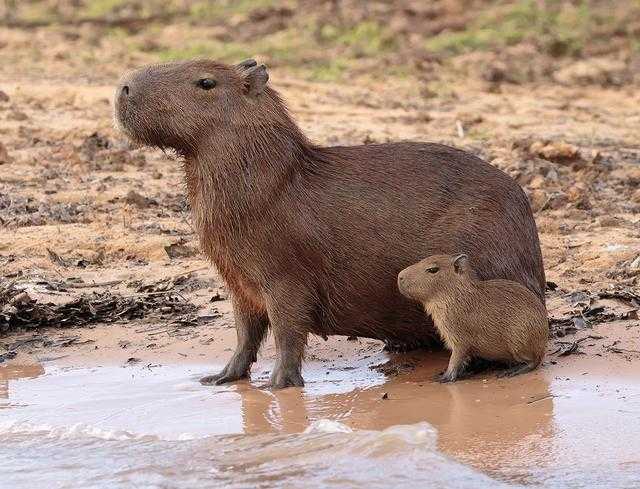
top-left (0, 2), bottom-right (640, 386)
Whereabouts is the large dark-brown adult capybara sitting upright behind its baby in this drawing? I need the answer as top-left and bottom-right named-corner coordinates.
top-left (115, 60), bottom-right (545, 387)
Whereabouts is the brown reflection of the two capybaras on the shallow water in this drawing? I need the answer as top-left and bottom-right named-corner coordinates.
top-left (236, 357), bottom-right (554, 482)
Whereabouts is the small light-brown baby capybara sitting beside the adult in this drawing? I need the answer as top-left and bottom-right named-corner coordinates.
top-left (398, 255), bottom-right (549, 382)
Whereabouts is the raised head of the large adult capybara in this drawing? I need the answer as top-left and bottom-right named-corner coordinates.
top-left (115, 60), bottom-right (281, 153)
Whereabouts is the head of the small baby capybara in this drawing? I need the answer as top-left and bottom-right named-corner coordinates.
top-left (398, 254), bottom-right (470, 302)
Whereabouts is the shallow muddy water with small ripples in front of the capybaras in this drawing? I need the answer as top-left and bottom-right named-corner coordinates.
top-left (0, 348), bottom-right (640, 488)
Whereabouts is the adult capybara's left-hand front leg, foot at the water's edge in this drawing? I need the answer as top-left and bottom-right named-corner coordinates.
top-left (200, 300), bottom-right (269, 385)
